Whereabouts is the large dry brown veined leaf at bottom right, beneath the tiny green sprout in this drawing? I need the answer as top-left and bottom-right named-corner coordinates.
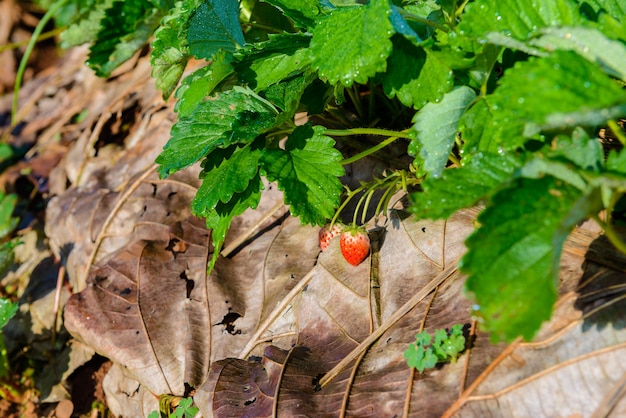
top-left (195, 214), bottom-right (626, 417)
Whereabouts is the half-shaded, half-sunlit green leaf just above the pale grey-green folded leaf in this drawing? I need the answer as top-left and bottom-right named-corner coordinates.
top-left (382, 35), bottom-right (454, 109)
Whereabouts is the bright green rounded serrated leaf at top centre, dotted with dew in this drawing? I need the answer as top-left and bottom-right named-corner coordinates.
top-left (311, 0), bottom-right (393, 87)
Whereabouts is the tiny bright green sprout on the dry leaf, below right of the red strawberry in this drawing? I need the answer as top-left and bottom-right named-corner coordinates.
top-left (404, 324), bottom-right (465, 373)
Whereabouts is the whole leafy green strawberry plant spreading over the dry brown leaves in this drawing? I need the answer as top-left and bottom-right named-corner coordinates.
top-left (29, 0), bottom-right (626, 340)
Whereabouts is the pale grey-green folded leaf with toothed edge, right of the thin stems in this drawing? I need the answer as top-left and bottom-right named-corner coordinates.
top-left (409, 86), bottom-right (476, 178)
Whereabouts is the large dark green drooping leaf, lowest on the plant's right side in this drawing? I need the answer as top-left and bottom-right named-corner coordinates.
top-left (460, 176), bottom-right (600, 341)
